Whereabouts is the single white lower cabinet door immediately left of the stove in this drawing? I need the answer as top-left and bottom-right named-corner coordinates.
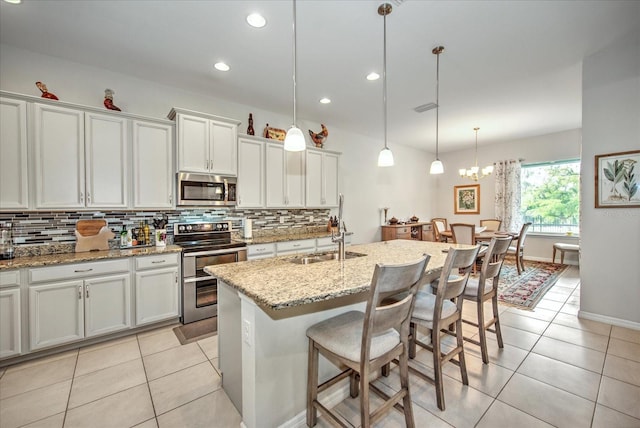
top-left (135, 267), bottom-right (180, 325)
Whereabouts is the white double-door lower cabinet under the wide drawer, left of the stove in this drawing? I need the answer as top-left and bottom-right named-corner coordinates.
top-left (29, 273), bottom-right (131, 351)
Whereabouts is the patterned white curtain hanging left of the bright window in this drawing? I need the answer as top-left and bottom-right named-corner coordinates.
top-left (494, 160), bottom-right (522, 232)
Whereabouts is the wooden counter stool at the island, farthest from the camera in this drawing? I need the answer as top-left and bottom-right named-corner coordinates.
top-left (462, 236), bottom-right (513, 364)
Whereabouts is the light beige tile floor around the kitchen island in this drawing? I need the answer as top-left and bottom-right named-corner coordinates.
top-left (0, 267), bottom-right (640, 428)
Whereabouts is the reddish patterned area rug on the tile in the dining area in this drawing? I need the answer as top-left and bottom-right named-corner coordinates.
top-left (498, 257), bottom-right (569, 310)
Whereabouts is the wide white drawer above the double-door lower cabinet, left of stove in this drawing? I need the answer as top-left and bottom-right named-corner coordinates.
top-left (29, 259), bottom-right (129, 284)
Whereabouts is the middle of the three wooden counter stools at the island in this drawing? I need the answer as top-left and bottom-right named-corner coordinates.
top-left (409, 246), bottom-right (479, 410)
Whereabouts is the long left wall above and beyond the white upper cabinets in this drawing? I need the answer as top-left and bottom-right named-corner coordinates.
top-left (0, 45), bottom-right (434, 243)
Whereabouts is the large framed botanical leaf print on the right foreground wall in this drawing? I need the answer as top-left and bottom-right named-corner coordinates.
top-left (595, 150), bottom-right (640, 208)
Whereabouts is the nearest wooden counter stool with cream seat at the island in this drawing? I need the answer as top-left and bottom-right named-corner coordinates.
top-left (307, 254), bottom-right (430, 427)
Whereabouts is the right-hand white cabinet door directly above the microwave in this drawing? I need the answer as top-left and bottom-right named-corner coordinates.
top-left (210, 120), bottom-right (238, 176)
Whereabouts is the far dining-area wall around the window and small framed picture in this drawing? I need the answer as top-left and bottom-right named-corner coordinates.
top-left (433, 124), bottom-right (582, 264)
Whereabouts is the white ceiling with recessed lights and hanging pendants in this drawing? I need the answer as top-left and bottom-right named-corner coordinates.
top-left (0, 0), bottom-right (640, 152)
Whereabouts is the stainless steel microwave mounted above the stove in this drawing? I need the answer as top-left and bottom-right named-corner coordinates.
top-left (177, 172), bottom-right (237, 206)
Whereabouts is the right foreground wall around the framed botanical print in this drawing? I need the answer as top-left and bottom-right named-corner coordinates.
top-left (580, 28), bottom-right (640, 329)
